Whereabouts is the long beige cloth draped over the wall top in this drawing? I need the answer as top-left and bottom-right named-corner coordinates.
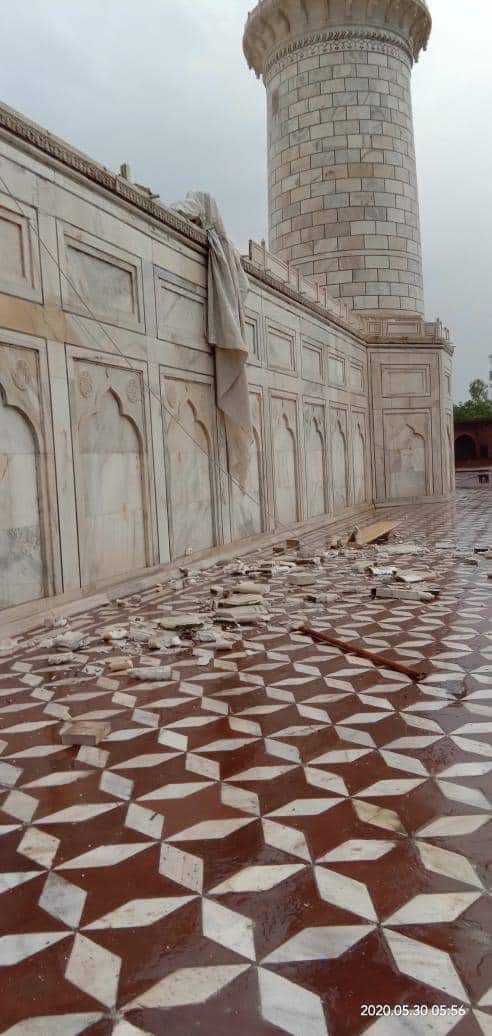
top-left (172, 191), bottom-right (253, 487)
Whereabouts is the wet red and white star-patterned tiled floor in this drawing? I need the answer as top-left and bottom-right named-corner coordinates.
top-left (0, 489), bottom-right (492, 1036)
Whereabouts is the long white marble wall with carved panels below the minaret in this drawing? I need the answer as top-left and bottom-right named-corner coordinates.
top-left (0, 106), bottom-right (453, 618)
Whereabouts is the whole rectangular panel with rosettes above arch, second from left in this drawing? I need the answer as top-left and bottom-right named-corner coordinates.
top-left (75, 361), bottom-right (149, 585)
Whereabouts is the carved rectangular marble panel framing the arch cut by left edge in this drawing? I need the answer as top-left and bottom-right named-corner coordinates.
top-left (0, 345), bottom-right (47, 608)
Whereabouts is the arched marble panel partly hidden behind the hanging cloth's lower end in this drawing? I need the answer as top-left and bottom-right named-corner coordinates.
top-left (232, 392), bottom-right (263, 540)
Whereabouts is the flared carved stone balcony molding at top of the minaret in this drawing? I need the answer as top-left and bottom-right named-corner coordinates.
top-left (243, 0), bottom-right (432, 76)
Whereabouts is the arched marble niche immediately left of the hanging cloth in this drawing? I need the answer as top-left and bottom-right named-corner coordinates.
top-left (167, 395), bottom-right (215, 557)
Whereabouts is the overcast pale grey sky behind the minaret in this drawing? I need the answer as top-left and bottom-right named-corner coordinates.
top-left (0, 0), bottom-right (492, 399)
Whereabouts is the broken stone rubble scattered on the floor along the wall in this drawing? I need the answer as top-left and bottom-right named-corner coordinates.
top-left (13, 522), bottom-right (492, 746)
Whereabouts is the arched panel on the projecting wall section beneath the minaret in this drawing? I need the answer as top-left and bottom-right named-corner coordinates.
top-left (384, 413), bottom-right (428, 499)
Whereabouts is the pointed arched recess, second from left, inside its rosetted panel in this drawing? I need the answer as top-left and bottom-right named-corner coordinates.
top-left (79, 389), bottom-right (147, 583)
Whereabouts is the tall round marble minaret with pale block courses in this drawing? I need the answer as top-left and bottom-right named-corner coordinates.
top-left (244, 0), bottom-right (432, 315)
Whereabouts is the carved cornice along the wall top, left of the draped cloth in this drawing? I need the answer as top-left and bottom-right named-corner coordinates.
top-left (0, 105), bottom-right (207, 247)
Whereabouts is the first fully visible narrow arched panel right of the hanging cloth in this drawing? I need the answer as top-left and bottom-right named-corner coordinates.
top-left (271, 397), bottom-right (299, 526)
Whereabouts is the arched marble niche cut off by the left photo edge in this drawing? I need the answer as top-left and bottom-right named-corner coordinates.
top-left (0, 383), bottom-right (46, 608)
